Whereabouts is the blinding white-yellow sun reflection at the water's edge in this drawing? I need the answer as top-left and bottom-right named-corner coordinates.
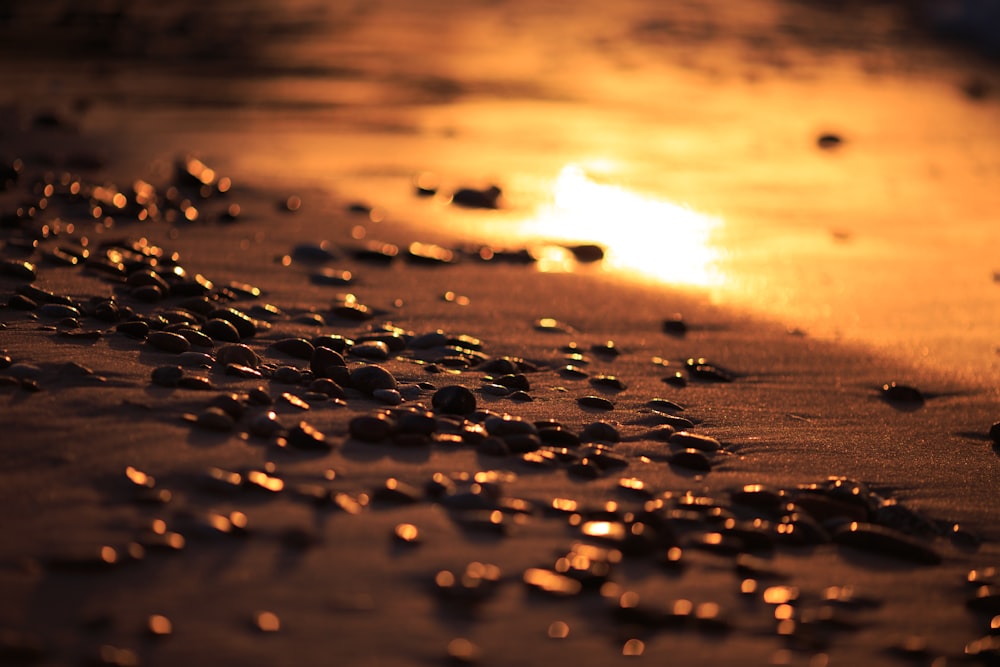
top-left (522, 164), bottom-right (723, 287)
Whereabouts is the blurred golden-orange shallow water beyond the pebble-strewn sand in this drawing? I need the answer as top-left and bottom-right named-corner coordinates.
top-left (2, 0), bottom-right (1000, 385)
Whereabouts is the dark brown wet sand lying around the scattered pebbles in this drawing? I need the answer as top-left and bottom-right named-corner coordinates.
top-left (0, 1), bottom-right (1000, 665)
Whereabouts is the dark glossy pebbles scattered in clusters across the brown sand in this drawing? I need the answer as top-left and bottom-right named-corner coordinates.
top-left (0, 158), bottom-right (1000, 665)
